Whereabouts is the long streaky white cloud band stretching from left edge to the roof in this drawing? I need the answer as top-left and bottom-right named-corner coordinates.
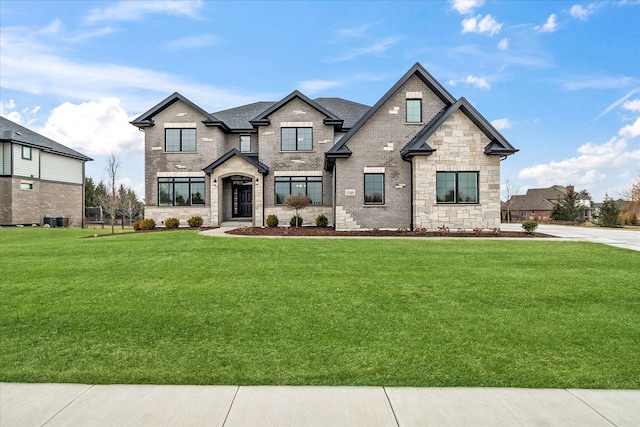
top-left (0, 27), bottom-right (261, 111)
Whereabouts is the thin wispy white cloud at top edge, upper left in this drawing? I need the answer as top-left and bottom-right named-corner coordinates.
top-left (85, 0), bottom-right (202, 24)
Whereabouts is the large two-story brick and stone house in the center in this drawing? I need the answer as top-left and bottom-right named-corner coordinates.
top-left (131, 64), bottom-right (518, 230)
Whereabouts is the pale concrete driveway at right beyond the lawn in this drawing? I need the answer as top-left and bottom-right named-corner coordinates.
top-left (500, 224), bottom-right (640, 251)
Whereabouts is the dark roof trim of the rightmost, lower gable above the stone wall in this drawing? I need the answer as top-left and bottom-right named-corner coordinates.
top-left (401, 97), bottom-right (518, 158)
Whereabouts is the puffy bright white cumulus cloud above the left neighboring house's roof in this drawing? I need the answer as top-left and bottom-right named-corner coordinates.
top-left (37, 98), bottom-right (144, 156)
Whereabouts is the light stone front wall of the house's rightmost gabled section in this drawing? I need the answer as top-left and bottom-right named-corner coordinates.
top-left (413, 111), bottom-right (500, 230)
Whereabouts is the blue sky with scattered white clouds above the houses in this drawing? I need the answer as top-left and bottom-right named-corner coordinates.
top-left (0, 0), bottom-right (640, 201)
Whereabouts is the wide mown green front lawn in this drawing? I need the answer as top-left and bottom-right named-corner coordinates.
top-left (0, 228), bottom-right (640, 389)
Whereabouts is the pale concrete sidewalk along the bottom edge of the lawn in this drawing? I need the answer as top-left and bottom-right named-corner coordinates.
top-left (0, 383), bottom-right (640, 427)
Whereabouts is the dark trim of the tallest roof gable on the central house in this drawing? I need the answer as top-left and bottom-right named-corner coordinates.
top-left (327, 62), bottom-right (456, 157)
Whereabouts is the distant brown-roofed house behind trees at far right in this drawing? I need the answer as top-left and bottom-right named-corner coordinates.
top-left (501, 185), bottom-right (592, 222)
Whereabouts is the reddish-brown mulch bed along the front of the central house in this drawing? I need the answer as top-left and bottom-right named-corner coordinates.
top-left (226, 227), bottom-right (554, 239)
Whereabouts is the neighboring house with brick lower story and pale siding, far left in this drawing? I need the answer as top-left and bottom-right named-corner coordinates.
top-left (0, 117), bottom-right (92, 226)
